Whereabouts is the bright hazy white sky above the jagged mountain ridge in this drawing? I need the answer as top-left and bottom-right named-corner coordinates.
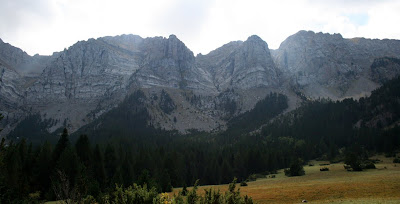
top-left (0, 0), bottom-right (400, 55)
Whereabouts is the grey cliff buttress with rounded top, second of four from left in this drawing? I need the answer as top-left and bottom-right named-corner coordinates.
top-left (133, 35), bottom-right (215, 93)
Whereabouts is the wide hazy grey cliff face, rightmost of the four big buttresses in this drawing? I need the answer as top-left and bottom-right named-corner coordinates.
top-left (274, 31), bottom-right (400, 99)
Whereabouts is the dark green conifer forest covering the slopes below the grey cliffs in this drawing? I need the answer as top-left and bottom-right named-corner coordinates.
top-left (0, 78), bottom-right (400, 203)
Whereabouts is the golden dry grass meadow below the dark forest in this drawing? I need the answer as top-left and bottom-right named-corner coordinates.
top-left (172, 156), bottom-right (400, 203)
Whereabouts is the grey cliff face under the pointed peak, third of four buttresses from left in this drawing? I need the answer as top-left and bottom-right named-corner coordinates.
top-left (196, 36), bottom-right (279, 91)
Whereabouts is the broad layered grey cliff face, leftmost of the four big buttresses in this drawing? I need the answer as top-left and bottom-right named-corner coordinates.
top-left (25, 36), bottom-right (139, 103)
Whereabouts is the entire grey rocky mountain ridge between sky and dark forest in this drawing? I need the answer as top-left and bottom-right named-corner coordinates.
top-left (0, 31), bottom-right (400, 136)
